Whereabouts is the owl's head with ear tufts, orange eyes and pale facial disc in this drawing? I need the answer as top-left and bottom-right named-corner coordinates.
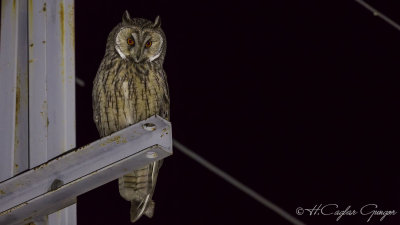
top-left (107, 11), bottom-right (167, 63)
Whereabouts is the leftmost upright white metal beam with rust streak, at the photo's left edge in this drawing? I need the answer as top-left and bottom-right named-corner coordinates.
top-left (0, 0), bottom-right (28, 181)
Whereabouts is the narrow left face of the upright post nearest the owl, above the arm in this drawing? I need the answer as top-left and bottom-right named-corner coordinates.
top-left (28, 0), bottom-right (51, 168)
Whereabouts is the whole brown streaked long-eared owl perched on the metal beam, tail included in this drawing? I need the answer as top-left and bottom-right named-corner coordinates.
top-left (92, 11), bottom-right (170, 223)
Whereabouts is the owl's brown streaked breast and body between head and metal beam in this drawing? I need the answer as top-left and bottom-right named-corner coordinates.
top-left (93, 58), bottom-right (169, 136)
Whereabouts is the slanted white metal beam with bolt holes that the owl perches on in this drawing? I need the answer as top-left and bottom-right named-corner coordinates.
top-left (0, 116), bottom-right (172, 225)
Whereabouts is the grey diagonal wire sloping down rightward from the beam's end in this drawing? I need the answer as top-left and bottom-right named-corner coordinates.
top-left (174, 139), bottom-right (305, 225)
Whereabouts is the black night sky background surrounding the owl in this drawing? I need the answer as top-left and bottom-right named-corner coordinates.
top-left (75, 0), bottom-right (400, 225)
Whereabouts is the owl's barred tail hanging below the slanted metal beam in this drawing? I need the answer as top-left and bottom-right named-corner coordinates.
top-left (118, 160), bottom-right (162, 223)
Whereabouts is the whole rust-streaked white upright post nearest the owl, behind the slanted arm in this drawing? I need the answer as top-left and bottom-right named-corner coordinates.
top-left (28, 0), bottom-right (76, 225)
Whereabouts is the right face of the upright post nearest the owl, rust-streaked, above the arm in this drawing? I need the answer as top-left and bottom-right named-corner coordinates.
top-left (45, 0), bottom-right (75, 158)
